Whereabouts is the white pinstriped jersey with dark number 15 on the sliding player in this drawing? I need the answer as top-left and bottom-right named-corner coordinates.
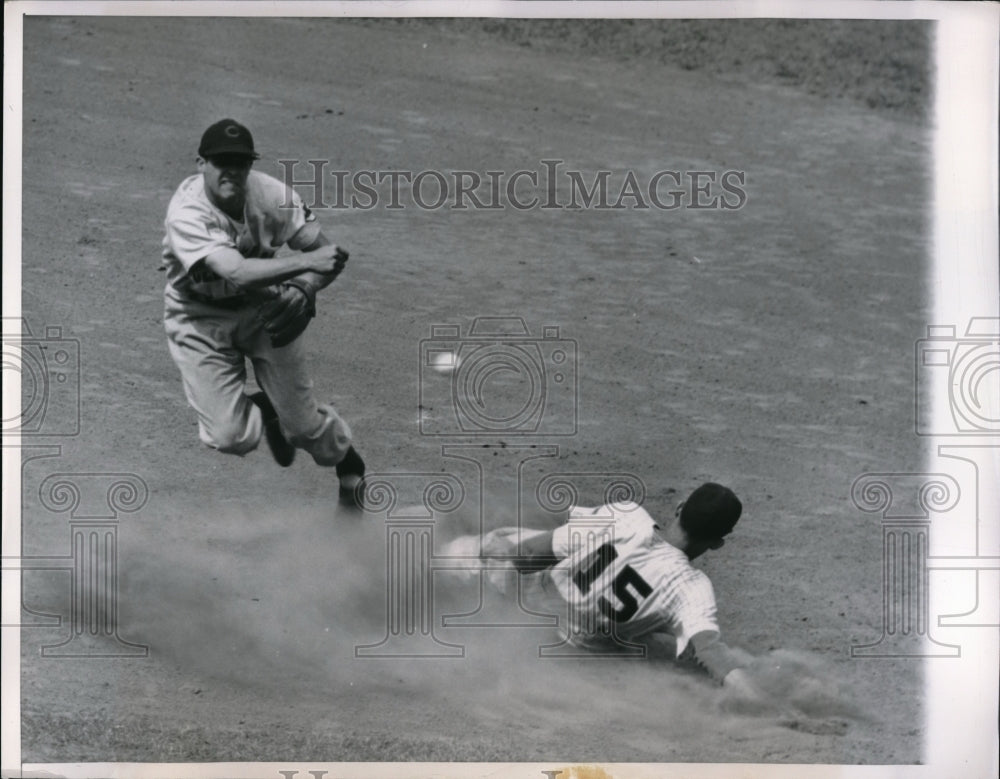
top-left (541, 503), bottom-right (719, 655)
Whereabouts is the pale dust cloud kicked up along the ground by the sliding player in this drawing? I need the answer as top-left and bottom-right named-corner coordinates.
top-left (115, 507), bottom-right (868, 759)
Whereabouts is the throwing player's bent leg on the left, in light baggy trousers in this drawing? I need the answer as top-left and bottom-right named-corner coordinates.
top-left (164, 299), bottom-right (263, 455)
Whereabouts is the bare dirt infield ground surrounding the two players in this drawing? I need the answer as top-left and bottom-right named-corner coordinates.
top-left (21, 12), bottom-right (931, 764)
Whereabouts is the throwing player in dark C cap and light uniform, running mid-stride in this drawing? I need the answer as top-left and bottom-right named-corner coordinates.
top-left (163, 119), bottom-right (365, 507)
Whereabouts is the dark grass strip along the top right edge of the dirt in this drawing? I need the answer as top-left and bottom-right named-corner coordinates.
top-left (355, 19), bottom-right (932, 118)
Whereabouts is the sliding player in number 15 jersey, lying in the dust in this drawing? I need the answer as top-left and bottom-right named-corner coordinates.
top-left (445, 483), bottom-right (764, 700)
